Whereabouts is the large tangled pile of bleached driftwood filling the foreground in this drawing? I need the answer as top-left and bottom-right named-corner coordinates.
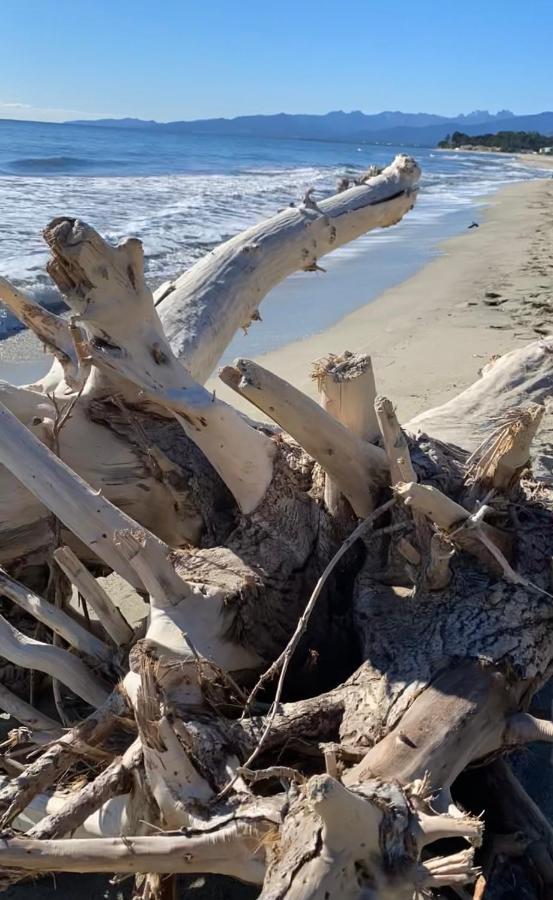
top-left (0, 151), bottom-right (553, 900)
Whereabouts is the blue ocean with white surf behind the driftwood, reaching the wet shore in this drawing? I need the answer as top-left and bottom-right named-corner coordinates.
top-left (0, 120), bottom-right (540, 344)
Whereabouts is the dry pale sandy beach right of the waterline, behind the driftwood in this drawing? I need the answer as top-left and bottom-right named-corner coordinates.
top-left (208, 168), bottom-right (553, 421)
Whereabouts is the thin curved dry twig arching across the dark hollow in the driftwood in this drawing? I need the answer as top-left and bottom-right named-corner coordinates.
top-left (214, 497), bottom-right (398, 800)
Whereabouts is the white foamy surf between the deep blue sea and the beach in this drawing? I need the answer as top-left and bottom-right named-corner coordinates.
top-left (0, 145), bottom-right (537, 334)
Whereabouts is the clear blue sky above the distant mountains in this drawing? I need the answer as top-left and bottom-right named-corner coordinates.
top-left (0, 0), bottom-right (553, 121)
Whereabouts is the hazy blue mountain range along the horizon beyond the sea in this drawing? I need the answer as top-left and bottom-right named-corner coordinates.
top-left (66, 109), bottom-right (553, 147)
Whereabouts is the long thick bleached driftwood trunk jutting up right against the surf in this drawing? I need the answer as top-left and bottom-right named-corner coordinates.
top-left (155, 156), bottom-right (420, 382)
